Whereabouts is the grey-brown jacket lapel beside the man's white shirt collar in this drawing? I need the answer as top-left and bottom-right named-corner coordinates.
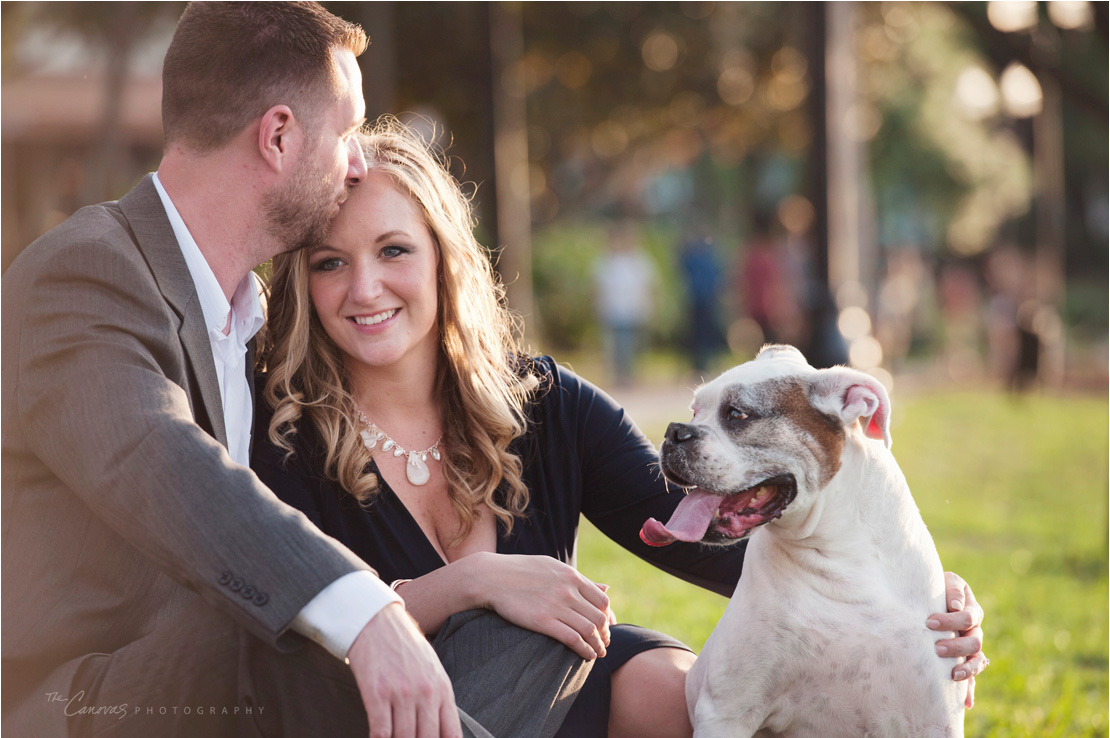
top-left (120, 174), bottom-right (228, 447)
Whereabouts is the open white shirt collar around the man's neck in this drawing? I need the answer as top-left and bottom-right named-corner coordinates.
top-left (153, 172), bottom-right (265, 343)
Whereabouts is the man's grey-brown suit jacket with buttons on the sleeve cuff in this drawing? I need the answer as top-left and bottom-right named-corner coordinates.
top-left (0, 175), bottom-right (369, 735)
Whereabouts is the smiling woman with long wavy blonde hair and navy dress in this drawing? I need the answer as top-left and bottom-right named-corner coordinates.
top-left (254, 122), bottom-right (985, 738)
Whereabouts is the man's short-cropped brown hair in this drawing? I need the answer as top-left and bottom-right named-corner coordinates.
top-left (162, 2), bottom-right (366, 151)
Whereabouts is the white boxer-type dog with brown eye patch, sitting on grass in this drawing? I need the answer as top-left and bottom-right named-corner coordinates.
top-left (640, 346), bottom-right (968, 738)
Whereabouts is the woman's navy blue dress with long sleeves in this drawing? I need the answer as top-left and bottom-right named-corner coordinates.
top-left (251, 356), bottom-right (744, 738)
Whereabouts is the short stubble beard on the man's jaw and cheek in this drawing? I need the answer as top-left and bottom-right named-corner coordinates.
top-left (262, 146), bottom-right (347, 252)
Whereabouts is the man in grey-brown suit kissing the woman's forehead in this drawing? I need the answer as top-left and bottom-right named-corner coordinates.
top-left (2, 2), bottom-right (585, 737)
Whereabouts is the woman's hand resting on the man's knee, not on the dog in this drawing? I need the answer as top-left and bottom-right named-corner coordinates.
top-left (474, 553), bottom-right (615, 659)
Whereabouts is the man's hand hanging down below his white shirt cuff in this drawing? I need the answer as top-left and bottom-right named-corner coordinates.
top-left (347, 603), bottom-right (463, 738)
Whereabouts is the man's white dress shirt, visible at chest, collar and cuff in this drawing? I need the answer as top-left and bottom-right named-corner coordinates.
top-left (153, 173), bottom-right (402, 658)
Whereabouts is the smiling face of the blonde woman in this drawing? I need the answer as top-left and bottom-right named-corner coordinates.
top-left (309, 171), bottom-right (438, 371)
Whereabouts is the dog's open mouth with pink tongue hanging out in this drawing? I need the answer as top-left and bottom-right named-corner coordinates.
top-left (639, 474), bottom-right (798, 546)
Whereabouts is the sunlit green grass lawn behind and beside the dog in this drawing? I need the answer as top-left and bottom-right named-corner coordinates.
top-left (578, 392), bottom-right (1108, 738)
